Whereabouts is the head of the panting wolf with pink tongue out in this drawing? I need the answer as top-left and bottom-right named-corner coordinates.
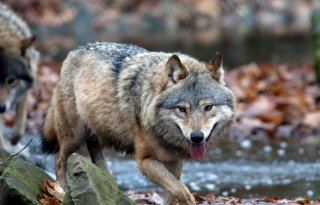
top-left (149, 53), bottom-right (235, 160)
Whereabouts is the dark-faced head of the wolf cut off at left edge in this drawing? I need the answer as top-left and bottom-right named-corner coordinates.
top-left (0, 37), bottom-right (34, 114)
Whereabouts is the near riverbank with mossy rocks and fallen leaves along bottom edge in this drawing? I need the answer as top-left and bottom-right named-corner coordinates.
top-left (0, 147), bottom-right (320, 205)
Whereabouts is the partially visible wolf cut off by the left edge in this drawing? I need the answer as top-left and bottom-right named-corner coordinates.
top-left (0, 3), bottom-right (39, 147)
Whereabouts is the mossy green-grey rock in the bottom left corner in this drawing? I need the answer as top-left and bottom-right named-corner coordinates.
top-left (0, 159), bottom-right (53, 205)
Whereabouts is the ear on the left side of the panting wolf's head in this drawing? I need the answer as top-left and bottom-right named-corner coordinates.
top-left (165, 55), bottom-right (188, 84)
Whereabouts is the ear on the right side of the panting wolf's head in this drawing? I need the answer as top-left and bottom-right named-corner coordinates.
top-left (206, 52), bottom-right (225, 84)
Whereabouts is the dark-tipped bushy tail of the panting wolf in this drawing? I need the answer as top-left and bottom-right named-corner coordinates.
top-left (41, 106), bottom-right (59, 154)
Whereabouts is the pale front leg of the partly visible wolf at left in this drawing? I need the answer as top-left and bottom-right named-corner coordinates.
top-left (10, 92), bottom-right (29, 145)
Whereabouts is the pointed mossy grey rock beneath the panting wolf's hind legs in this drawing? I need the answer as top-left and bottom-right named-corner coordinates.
top-left (63, 154), bottom-right (135, 205)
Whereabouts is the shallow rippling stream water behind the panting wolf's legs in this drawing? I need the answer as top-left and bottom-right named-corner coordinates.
top-left (4, 129), bottom-right (320, 199)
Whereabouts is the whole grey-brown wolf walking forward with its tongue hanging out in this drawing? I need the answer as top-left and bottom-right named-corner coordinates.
top-left (42, 42), bottom-right (235, 205)
